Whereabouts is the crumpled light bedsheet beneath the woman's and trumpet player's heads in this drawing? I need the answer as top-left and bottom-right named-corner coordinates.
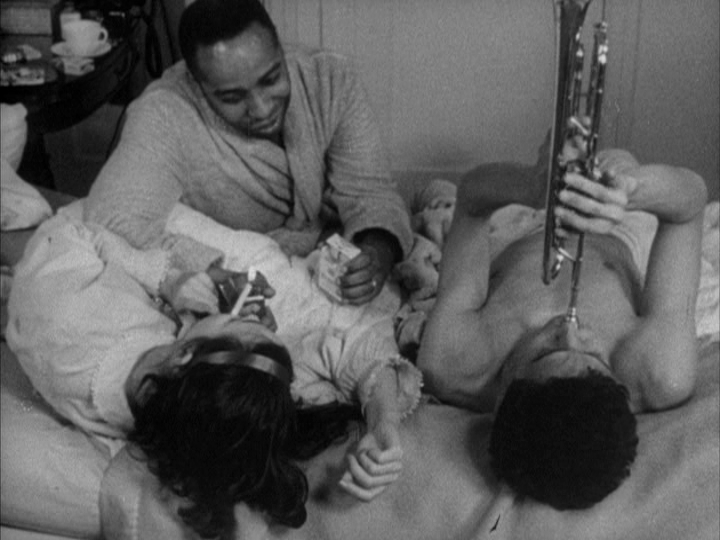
top-left (100, 343), bottom-right (720, 540)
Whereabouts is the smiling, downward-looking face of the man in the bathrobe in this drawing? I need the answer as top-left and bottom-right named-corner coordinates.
top-left (197, 24), bottom-right (290, 139)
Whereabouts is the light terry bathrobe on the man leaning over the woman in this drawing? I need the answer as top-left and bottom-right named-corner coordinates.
top-left (86, 44), bottom-right (412, 270)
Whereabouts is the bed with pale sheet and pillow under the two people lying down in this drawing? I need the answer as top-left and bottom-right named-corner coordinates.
top-left (0, 182), bottom-right (720, 540)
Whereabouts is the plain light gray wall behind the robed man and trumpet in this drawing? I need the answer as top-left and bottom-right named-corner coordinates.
top-left (51, 0), bottom-right (720, 199)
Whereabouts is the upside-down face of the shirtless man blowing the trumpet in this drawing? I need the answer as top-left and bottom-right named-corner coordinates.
top-left (501, 315), bottom-right (613, 394)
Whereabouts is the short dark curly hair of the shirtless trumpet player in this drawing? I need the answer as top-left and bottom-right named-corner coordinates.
top-left (490, 369), bottom-right (638, 510)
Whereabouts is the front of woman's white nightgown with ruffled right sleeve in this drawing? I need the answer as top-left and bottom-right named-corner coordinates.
top-left (167, 204), bottom-right (410, 404)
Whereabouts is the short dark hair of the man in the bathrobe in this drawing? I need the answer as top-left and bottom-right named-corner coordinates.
top-left (178, 0), bottom-right (280, 77)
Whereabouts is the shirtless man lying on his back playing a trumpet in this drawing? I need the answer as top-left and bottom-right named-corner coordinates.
top-left (418, 151), bottom-right (707, 509)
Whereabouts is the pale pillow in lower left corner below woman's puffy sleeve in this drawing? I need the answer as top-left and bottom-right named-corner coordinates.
top-left (0, 343), bottom-right (110, 538)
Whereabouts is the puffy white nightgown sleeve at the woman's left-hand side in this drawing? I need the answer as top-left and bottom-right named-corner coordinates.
top-left (6, 207), bottom-right (175, 437)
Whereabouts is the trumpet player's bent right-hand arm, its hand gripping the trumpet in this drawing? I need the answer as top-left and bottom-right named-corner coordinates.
top-left (559, 148), bottom-right (707, 410)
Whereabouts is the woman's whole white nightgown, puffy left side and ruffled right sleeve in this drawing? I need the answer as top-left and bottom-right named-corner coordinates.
top-left (7, 201), bottom-right (414, 437)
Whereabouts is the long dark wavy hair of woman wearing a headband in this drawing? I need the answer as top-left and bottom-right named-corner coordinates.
top-left (128, 338), bottom-right (361, 538)
